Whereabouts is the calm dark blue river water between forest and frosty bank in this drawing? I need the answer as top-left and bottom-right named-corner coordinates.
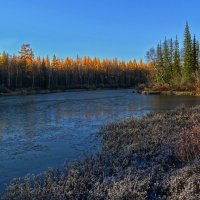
top-left (0, 89), bottom-right (200, 191)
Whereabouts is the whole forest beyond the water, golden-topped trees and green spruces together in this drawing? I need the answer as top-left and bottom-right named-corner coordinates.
top-left (0, 23), bottom-right (200, 92)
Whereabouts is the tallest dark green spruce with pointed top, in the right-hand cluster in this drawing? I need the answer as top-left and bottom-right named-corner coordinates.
top-left (183, 22), bottom-right (193, 82)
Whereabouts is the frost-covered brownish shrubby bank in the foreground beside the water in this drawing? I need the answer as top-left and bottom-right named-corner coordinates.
top-left (2, 106), bottom-right (200, 200)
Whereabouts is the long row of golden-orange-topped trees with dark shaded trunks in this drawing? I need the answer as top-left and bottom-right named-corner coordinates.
top-left (0, 44), bottom-right (150, 89)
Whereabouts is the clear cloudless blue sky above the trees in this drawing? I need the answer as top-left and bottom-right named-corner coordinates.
top-left (0, 0), bottom-right (200, 61)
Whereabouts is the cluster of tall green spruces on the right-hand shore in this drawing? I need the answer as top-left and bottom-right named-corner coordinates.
top-left (147, 22), bottom-right (200, 86)
